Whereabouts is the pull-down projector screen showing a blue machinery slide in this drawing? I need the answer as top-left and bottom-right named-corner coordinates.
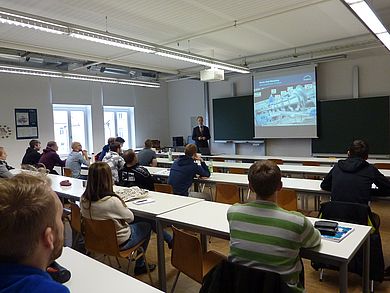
top-left (253, 66), bottom-right (317, 138)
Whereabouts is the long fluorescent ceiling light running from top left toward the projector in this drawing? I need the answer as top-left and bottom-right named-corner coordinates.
top-left (0, 8), bottom-right (250, 73)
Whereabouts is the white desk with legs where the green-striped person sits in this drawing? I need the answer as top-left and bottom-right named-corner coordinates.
top-left (156, 201), bottom-right (371, 293)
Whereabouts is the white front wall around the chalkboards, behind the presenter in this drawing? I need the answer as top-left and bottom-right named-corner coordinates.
top-left (168, 52), bottom-right (390, 156)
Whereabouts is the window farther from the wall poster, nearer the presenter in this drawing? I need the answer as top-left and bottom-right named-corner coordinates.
top-left (104, 107), bottom-right (135, 149)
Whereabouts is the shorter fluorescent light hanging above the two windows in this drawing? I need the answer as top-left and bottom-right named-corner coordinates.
top-left (0, 65), bottom-right (160, 88)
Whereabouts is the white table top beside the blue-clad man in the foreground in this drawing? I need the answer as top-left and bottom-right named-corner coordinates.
top-left (57, 247), bottom-right (162, 293)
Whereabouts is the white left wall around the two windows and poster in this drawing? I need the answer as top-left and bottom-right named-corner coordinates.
top-left (0, 74), bottom-right (169, 167)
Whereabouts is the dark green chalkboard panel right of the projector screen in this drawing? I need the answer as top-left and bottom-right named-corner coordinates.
top-left (312, 97), bottom-right (390, 155)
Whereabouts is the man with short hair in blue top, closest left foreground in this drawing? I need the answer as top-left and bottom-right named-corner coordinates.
top-left (0, 174), bottom-right (69, 293)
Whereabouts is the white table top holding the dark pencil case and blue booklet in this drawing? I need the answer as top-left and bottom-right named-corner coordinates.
top-left (157, 201), bottom-right (371, 260)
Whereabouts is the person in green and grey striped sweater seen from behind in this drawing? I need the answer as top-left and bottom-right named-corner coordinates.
top-left (227, 161), bottom-right (321, 292)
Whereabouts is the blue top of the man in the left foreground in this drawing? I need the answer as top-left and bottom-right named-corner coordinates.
top-left (0, 263), bottom-right (69, 293)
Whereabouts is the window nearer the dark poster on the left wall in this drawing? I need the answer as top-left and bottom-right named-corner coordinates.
top-left (53, 105), bottom-right (91, 154)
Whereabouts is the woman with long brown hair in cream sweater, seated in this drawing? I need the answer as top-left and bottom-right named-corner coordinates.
top-left (80, 162), bottom-right (156, 275)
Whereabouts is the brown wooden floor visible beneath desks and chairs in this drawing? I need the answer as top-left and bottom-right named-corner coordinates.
top-left (64, 197), bottom-right (390, 293)
